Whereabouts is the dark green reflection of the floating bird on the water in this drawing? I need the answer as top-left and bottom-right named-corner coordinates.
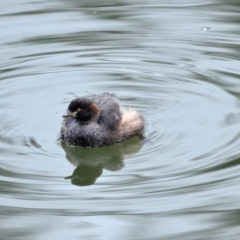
top-left (61, 136), bottom-right (143, 186)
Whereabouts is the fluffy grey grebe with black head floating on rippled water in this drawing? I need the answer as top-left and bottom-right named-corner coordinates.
top-left (61, 93), bottom-right (144, 147)
